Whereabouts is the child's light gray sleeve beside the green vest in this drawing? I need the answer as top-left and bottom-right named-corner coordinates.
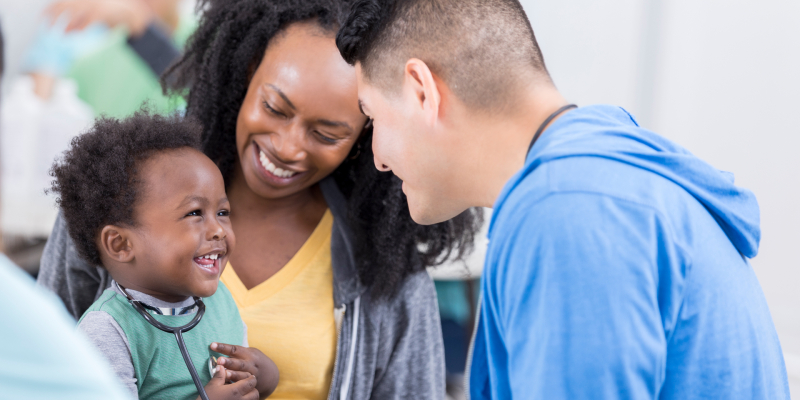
top-left (78, 311), bottom-right (139, 398)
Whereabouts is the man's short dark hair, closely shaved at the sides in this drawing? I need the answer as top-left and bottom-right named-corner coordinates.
top-left (336, 0), bottom-right (550, 109)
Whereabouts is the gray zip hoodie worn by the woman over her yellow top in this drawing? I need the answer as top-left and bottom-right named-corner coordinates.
top-left (38, 178), bottom-right (445, 400)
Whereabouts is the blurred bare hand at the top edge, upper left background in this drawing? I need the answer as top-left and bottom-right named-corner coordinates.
top-left (45, 0), bottom-right (155, 37)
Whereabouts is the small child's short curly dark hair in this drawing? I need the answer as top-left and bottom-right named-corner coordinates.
top-left (50, 107), bottom-right (202, 265)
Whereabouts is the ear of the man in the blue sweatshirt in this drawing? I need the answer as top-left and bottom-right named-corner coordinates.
top-left (403, 58), bottom-right (443, 125)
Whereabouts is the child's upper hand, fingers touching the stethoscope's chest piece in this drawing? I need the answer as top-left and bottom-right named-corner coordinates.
top-left (211, 343), bottom-right (278, 399)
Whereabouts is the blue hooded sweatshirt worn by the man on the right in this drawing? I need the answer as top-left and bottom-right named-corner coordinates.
top-left (468, 106), bottom-right (789, 400)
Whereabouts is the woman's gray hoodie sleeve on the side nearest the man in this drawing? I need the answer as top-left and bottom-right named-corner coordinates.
top-left (366, 271), bottom-right (445, 400)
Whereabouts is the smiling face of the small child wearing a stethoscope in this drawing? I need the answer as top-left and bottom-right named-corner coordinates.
top-left (125, 149), bottom-right (235, 301)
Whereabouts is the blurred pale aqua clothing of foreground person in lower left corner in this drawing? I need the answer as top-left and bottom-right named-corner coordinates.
top-left (0, 24), bottom-right (130, 400)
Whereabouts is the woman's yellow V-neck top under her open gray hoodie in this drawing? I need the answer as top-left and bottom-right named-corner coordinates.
top-left (220, 210), bottom-right (336, 400)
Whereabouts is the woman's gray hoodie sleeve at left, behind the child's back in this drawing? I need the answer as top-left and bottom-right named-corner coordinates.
top-left (37, 213), bottom-right (111, 319)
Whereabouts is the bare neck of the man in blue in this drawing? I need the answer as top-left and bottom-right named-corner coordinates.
top-left (473, 87), bottom-right (568, 207)
